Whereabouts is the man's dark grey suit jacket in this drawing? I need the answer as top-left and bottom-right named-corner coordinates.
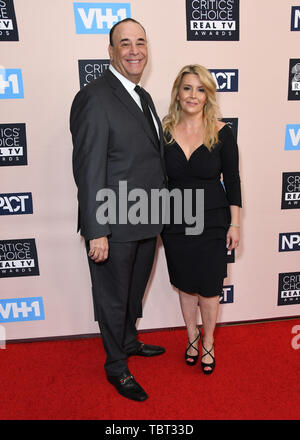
top-left (70, 70), bottom-right (167, 241)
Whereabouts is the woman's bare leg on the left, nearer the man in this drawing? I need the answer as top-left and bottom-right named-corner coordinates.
top-left (179, 290), bottom-right (199, 356)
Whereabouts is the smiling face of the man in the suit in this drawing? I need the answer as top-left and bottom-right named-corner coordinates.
top-left (108, 21), bottom-right (148, 84)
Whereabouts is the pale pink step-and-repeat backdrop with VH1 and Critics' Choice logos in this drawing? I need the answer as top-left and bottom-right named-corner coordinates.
top-left (0, 0), bottom-right (300, 340)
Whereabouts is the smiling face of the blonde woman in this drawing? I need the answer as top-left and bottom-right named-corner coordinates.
top-left (177, 73), bottom-right (207, 115)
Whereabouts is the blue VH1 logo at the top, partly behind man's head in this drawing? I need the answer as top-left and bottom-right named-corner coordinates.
top-left (73, 3), bottom-right (131, 34)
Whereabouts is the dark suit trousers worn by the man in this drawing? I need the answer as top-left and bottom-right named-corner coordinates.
top-left (87, 237), bottom-right (156, 375)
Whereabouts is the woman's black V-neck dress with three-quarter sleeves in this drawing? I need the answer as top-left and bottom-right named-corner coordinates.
top-left (161, 125), bottom-right (241, 297)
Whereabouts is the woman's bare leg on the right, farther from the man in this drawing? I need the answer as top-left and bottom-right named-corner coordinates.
top-left (199, 295), bottom-right (220, 371)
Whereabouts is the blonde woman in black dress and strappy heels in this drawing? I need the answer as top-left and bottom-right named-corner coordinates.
top-left (162, 65), bottom-right (241, 374)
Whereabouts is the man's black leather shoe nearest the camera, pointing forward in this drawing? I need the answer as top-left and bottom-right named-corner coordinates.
top-left (107, 372), bottom-right (148, 402)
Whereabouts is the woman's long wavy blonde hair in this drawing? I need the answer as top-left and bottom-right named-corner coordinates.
top-left (162, 64), bottom-right (219, 150)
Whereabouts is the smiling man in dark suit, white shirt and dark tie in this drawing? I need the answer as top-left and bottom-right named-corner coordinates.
top-left (70, 19), bottom-right (166, 401)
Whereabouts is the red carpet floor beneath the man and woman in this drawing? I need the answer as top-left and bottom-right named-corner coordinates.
top-left (0, 319), bottom-right (300, 420)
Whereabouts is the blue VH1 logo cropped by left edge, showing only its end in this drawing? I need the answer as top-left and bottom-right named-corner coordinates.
top-left (0, 66), bottom-right (24, 99)
